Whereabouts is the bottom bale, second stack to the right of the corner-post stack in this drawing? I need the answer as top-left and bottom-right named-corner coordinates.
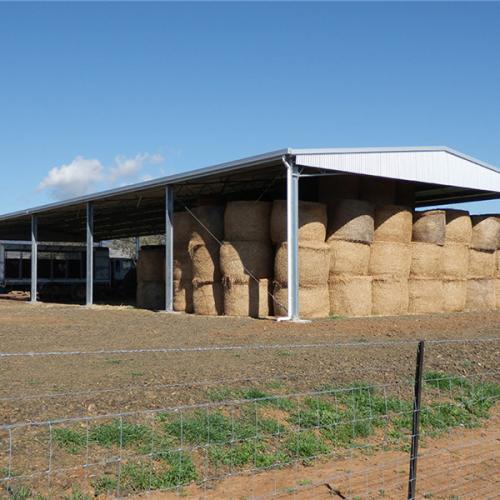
top-left (372, 278), bottom-right (408, 316)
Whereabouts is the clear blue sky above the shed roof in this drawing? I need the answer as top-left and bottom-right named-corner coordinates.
top-left (0, 2), bottom-right (500, 213)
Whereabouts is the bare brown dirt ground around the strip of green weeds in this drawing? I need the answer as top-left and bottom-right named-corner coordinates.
top-left (0, 299), bottom-right (500, 499)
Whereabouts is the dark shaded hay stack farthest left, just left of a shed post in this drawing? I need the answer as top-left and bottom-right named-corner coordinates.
top-left (136, 245), bottom-right (165, 310)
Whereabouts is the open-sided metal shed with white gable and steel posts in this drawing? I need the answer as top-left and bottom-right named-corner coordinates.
top-left (0, 147), bottom-right (500, 320)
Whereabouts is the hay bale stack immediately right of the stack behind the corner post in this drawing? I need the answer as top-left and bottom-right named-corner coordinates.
top-left (327, 199), bottom-right (374, 316)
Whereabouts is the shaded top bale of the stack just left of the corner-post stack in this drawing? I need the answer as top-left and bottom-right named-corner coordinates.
top-left (224, 201), bottom-right (271, 242)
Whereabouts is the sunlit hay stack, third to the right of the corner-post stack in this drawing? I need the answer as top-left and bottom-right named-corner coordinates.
top-left (408, 210), bottom-right (446, 313)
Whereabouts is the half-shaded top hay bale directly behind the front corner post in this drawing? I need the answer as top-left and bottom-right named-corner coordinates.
top-left (271, 200), bottom-right (327, 244)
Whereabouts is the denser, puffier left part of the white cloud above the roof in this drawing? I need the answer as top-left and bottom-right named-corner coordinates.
top-left (38, 156), bottom-right (104, 200)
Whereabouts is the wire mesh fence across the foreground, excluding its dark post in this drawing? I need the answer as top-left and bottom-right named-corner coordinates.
top-left (0, 338), bottom-right (500, 499)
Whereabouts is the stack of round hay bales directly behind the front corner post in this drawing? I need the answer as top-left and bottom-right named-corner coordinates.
top-left (271, 200), bottom-right (330, 318)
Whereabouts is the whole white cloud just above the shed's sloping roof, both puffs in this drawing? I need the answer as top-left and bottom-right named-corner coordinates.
top-left (38, 153), bottom-right (164, 200)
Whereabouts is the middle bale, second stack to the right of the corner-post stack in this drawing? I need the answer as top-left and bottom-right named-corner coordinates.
top-left (368, 241), bottom-right (411, 278)
